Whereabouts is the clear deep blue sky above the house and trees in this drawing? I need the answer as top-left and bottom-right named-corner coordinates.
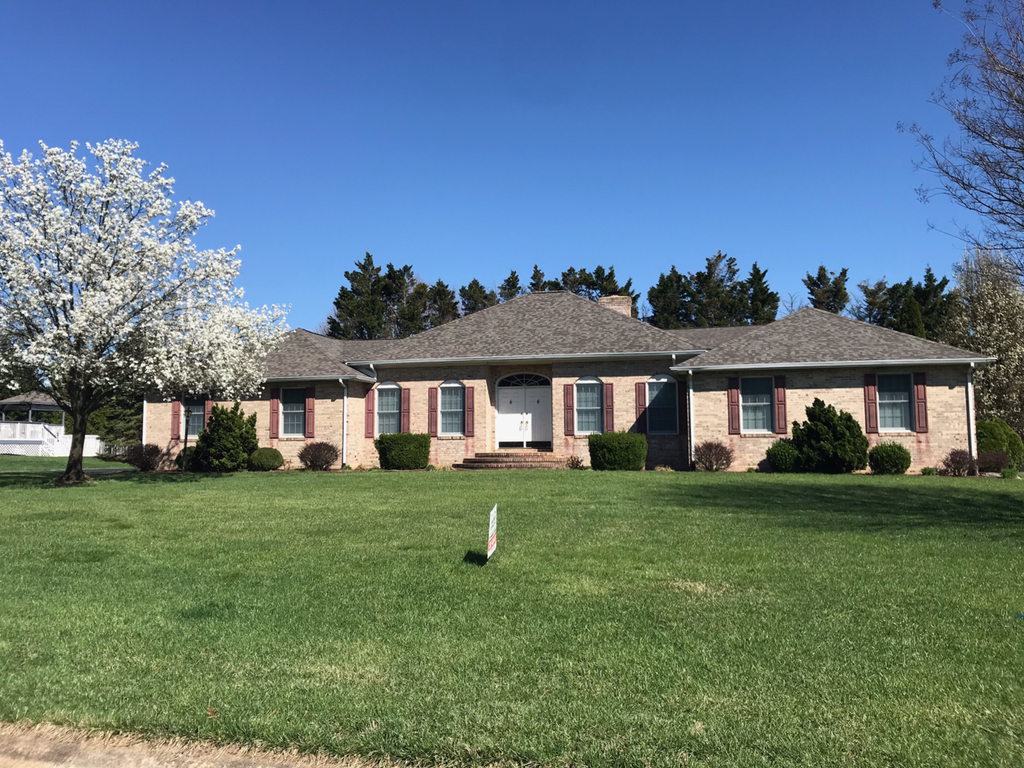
top-left (0, 0), bottom-right (972, 329)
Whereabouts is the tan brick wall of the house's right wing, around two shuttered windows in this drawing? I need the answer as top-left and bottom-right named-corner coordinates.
top-left (693, 366), bottom-right (968, 471)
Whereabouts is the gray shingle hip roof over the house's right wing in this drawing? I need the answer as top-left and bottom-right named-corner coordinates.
top-left (677, 307), bottom-right (989, 370)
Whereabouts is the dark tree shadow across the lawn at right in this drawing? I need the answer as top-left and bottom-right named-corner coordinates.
top-left (659, 475), bottom-right (1024, 538)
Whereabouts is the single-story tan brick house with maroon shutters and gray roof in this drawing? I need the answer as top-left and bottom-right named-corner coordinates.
top-left (143, 292), bottom-right (992, 471)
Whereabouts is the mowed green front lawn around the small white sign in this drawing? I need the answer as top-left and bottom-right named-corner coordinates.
top-left (0, 471), bottom-right (1024, 766)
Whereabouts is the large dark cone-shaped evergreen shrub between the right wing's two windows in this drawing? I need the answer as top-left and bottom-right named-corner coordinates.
top-left (793, 397), bottom-right (867, 475)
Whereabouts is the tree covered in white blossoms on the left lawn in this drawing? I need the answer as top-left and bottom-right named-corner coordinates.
top-left (0, 139), bottom-right (286, 482)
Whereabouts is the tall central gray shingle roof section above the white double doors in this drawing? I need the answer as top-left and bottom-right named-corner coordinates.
top-left (349, 292), bottom-right (703, 361)
